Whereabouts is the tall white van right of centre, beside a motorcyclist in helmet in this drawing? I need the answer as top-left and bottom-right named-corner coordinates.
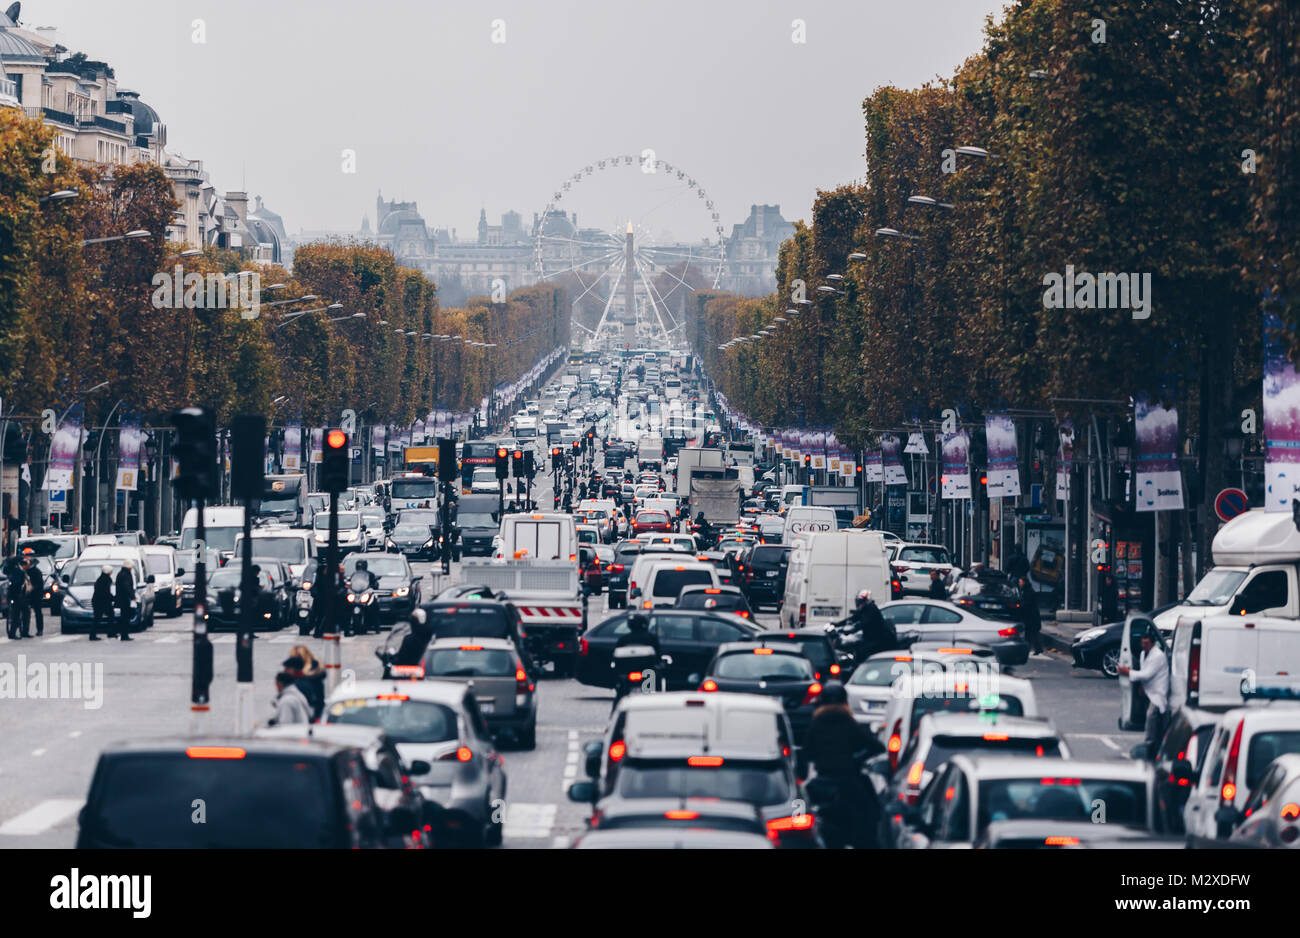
top-left (780, 529), bottom-right (889, 629)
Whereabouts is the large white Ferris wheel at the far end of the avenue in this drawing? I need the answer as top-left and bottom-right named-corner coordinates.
top-left (533, 149), bottom-right (727, 336)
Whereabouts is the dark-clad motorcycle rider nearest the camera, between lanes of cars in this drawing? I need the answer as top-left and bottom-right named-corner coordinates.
top-left (803, 681), bottom-right (885, 850)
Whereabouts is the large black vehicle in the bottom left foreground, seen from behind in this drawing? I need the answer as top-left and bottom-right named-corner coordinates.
top-left (77, 737), bottom-right (395, 850)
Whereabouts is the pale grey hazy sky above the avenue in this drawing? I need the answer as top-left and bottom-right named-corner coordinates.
top-left (22, 0), bottom-right (1002, 239)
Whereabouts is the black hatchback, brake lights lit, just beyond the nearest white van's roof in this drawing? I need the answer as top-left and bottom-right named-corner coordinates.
top-left (699, 634), bottom-right (822, 742)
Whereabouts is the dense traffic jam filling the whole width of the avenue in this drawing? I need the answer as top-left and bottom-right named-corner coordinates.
top-left (10, 347), bottom-right (1300, 850)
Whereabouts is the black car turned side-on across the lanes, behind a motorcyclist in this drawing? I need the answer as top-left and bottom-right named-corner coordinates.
top-left (577, 609), bottom-right (759, 690)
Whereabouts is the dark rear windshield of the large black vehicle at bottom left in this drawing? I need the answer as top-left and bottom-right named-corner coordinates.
top-left (90, 752), bottom-right (342, 850)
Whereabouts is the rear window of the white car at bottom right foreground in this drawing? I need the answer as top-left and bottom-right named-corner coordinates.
top-left (979, 773), bottom-right (1147, 830)
